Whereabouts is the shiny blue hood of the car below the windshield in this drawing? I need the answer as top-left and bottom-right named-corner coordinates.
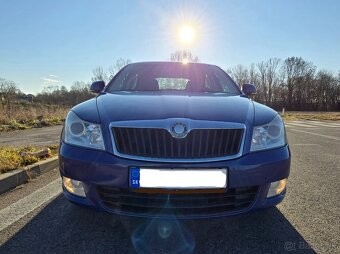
top-left (97, 92), bottom-right (254, 124)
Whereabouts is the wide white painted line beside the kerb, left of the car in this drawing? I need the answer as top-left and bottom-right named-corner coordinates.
top-left (0, 178), bottom-right (61, 231)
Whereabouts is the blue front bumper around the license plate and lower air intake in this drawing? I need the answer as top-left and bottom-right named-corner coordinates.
top-left (59, 142), bottom-right (290, 219)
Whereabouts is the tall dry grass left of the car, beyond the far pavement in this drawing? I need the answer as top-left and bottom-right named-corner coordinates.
top-left (0, 103), bottom-right (69, 132)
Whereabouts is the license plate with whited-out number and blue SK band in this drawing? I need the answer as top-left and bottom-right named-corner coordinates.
top-left (130, 167), bottom-right (227, 189)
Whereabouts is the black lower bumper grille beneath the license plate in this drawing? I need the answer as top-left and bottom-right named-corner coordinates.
top-left (97, 186), bottom-right (258, 217)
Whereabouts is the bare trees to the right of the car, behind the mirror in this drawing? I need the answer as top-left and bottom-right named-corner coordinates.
top-left (226, 57), bottom-right (340, 111)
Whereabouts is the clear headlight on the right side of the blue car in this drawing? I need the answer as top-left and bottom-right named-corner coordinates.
top-left (250, 115), bottom-right (287, 151)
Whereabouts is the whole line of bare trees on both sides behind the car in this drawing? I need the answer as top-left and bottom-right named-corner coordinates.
top-left (0, 54), bottom-right (340, 111)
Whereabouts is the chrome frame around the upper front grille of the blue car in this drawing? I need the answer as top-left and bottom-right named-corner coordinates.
top-left (109, 118), bottom-right (246, 162)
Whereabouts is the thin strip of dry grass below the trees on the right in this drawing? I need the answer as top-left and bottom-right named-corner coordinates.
top-left (281, 111), bottom-right (340, 121)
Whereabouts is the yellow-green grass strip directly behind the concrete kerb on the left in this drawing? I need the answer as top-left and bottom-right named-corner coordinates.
top-left (0, 145), bottom-right (59, 174)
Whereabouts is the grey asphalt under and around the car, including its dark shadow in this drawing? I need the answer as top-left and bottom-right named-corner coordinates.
top-left (0, 121), bottom-right (340, 253)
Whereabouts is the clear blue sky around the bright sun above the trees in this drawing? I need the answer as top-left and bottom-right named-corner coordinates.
top-left (0, 0), bottom-right (340, 94)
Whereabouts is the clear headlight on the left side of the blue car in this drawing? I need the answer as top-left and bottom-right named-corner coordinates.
top-left (63, 111), bottom-right (105, 150)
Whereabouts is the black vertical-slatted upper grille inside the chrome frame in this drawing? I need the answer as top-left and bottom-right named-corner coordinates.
top-left (112, 127), bottom-right (244, 159)
